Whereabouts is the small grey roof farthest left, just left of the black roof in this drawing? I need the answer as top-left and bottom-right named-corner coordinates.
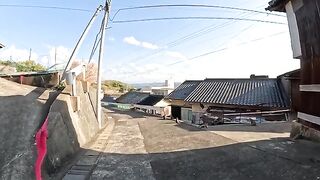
top-left (116, 91), bottom-right (150, 104)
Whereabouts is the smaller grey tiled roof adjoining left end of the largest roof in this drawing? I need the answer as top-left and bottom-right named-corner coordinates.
top-left (166, 81), bottom-right (201, 100)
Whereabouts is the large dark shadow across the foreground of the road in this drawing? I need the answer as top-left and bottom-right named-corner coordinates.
top-left (77, 139), bottom-right (320, 180)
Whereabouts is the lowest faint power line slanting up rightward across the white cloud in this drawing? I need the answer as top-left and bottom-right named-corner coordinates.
top-left (127, 31), bottom-right (286, 76)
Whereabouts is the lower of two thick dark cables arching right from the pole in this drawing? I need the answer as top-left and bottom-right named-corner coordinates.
top-left (113, 16), bottom-right (286, 25)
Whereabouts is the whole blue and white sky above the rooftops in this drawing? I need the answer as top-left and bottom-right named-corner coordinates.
top-left (0, 0), bottom-right (299, 83)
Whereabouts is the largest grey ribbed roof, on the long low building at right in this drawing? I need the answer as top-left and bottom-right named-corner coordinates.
top-left (185, 79), bottom-right (288, 108)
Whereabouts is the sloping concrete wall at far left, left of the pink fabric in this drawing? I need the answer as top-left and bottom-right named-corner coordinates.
top-left (0, 78), bottom-right (57, 180)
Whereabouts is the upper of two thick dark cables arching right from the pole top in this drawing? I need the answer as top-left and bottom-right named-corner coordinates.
top-left (111, 4), bottom-right (286, 21)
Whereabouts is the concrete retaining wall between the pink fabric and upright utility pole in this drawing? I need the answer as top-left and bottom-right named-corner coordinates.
top-left (45, 82), bottom-right (99, 174)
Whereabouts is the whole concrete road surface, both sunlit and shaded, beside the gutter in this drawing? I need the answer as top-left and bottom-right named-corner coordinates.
top-left (85, 108), bottom-right (320, 180)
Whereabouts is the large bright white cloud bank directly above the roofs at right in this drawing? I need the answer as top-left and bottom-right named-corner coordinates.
top-left (106, 26), bottom-right (300, 83)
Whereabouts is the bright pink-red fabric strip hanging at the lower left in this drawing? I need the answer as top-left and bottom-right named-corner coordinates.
top-left (35, 117), bottom-right (48, 180)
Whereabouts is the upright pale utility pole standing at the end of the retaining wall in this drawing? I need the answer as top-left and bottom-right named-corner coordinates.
top-left (96, 0), bottom-right (111, 129)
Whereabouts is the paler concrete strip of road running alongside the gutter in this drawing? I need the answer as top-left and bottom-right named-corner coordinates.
top-left (91, 114), bottom-right (154, 180)
